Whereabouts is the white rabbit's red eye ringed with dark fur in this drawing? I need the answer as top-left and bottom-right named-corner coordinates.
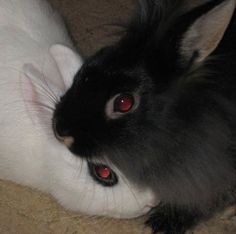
top-left (88, 163), bottom-right (118, 186)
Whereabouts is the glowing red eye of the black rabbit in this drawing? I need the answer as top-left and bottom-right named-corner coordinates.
top-left (114, 94), bottom-right (134, 113)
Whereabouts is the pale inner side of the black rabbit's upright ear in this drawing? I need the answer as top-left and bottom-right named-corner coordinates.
top-left (180, 0), bottom-right (236, 62)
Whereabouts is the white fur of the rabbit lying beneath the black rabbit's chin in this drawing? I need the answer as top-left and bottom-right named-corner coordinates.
top-left (0, 0), bottom-right (157, 218)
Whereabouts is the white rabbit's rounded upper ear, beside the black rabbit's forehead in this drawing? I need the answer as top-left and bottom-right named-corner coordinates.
top-left (50, 44), bottom-right (82, 88)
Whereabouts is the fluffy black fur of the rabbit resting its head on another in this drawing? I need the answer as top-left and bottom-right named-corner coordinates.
top-left (54, 0), bottom-right (236, 234)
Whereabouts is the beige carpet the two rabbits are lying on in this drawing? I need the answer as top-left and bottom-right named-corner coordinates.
top-left (0, 0), bottom-right (236, 234)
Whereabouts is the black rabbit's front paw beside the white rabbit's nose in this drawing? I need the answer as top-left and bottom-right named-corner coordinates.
top-left (146, 205), bottom-right (201, 234)
